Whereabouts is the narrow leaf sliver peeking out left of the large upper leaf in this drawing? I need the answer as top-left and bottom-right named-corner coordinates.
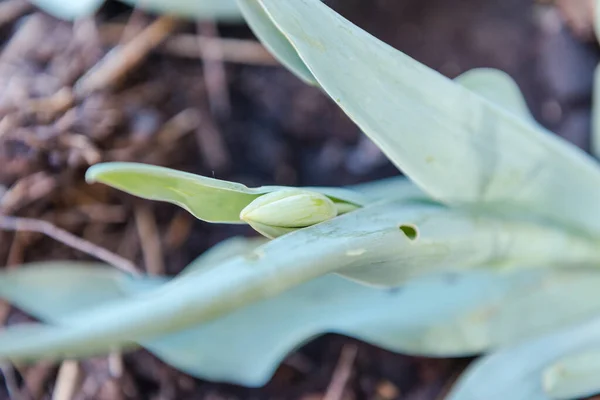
top-left (237, 0), bottom-right (317, 85)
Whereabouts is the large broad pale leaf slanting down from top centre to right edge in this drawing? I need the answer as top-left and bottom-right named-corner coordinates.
top-left (259, 0), bottom-right (600, 235)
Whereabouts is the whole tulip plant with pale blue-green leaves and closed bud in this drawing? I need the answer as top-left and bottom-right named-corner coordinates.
top-left (0, 0), bottom-right (600, 400)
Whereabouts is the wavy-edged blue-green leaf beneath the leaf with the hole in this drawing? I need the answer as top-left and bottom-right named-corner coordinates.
top-left (144, 271), bottom-right (600, 386)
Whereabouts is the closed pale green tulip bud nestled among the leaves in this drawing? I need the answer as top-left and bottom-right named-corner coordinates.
top-left (240, 189), bottom-right (337, 228)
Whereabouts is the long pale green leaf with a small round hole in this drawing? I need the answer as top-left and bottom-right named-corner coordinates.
top-left (0, 202), bottom-right (600, 360)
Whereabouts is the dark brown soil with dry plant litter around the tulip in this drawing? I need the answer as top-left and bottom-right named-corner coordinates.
top-left (0, 0), bottom-right (600, 400)
